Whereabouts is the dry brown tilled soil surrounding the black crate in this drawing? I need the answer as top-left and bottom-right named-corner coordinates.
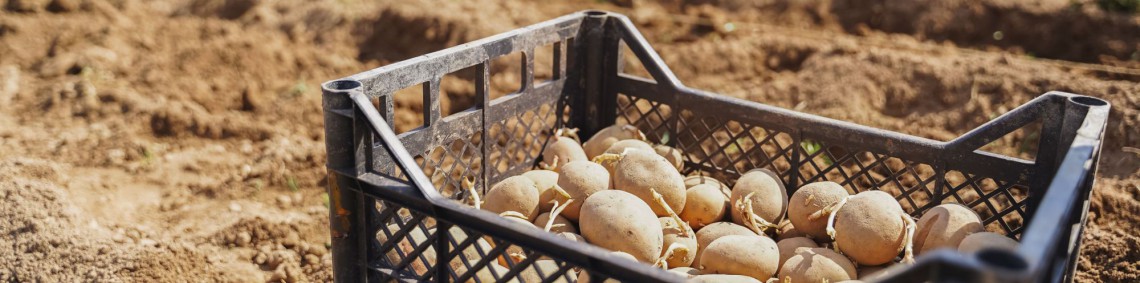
top-left (0, 0), bottom-right (1140, 282)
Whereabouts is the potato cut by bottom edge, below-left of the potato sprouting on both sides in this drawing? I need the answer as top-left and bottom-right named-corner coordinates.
top-left (780, 248), bottom-right (857, 282)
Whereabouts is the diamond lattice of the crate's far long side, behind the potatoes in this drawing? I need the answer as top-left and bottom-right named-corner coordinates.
top-left (618, 95), bottom-right (1028, 237)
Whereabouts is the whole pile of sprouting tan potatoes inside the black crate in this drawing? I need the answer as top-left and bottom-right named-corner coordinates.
top-left (458, 126), bottom-right (1017, 283)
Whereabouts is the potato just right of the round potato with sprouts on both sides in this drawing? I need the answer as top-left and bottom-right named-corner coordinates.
top-left (914, 203), bottom-right (985, 254)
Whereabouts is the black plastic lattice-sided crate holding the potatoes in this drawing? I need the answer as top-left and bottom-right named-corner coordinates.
top-left (324, 11), bottom-right (1109, 282)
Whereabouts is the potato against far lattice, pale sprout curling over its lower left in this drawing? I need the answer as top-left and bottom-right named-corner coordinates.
top-left (728, 169), bottom-right (788, 229)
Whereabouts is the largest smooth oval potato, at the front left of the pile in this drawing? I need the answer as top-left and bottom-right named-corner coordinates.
top-left (578, 189), bottom-right (665, 262)
